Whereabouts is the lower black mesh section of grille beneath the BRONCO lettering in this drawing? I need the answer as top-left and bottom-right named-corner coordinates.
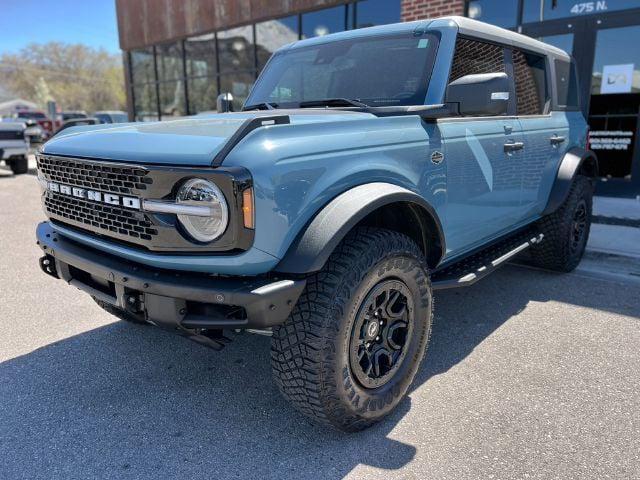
top-left (44, 193), bottom-right (158, 240)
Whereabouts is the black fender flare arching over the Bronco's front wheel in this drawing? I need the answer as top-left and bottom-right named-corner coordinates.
top-left (275, 182), bottom-right (446, 274)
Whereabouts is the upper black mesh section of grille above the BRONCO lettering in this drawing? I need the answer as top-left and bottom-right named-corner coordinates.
top-left (38, 157), bottom-right (153, 195)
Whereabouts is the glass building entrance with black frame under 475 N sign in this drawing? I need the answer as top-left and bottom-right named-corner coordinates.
top-left (523, 10), bottom-right (640, 197)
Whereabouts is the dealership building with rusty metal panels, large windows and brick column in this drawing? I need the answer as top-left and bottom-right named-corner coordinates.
top-left (116, 0), bottom-right (640, 197)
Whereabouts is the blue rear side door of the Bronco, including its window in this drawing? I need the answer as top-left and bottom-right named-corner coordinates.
top-left (511, 49), bottom-right (569, 219)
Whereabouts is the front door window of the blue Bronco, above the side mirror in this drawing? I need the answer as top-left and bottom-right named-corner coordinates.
top-left (449, 38), bottom-right (505, 82)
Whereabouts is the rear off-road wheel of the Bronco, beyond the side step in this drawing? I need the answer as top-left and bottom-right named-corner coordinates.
top-left (530, 175), bottom-right (593, 272)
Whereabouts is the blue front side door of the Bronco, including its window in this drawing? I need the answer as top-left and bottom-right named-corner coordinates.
top-left (438, 38), bottom-right (524, 256)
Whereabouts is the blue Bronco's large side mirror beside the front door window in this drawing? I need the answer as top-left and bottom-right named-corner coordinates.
top-left (447, 73), bottom-right (511, 116)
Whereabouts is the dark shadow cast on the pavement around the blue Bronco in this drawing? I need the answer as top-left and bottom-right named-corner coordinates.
top-left (0, 267), bottom-right (638, 478)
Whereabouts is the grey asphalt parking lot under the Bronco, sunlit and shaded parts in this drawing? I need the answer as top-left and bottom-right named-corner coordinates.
top-left (0, 166), bottom-right (640, 479)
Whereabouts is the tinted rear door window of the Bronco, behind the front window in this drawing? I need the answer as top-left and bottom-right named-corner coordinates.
top-left (513, 50), bottom-right (548, 115)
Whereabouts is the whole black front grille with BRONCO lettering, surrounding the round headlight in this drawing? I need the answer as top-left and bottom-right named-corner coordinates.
top-left (36, 153), bottom-right (253, 253)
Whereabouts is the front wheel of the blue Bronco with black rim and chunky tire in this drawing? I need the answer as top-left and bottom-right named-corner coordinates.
top-left (271, 228), bottom-right (433, 431)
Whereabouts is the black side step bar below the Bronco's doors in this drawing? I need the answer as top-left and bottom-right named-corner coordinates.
top-left (431, 233), bottom-right (544, 290)
